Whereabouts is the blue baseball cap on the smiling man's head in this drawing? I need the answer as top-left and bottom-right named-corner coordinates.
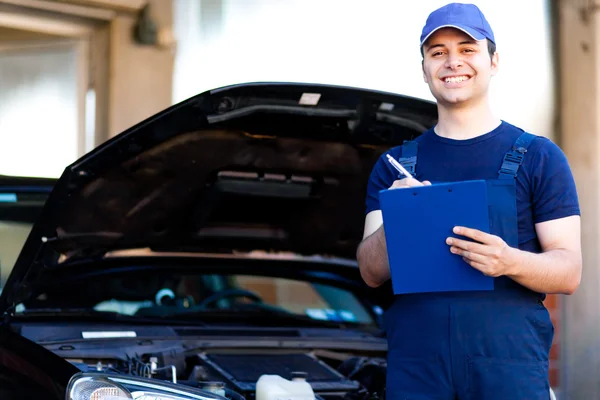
top-left (421, 3), bottom-right (496, 46)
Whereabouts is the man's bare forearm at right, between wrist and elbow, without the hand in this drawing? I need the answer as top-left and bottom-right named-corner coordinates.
top-left (507, 249), bottom-right (582, 294)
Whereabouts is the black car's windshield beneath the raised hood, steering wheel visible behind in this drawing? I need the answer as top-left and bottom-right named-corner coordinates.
top-left (17, 272), bottom-right (375, 325)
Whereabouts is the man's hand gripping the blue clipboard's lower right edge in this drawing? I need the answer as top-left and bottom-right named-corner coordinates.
top-left (446, 227), bottom-right (519, 278)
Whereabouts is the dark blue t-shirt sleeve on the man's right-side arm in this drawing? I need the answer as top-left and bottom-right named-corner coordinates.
top-left (531, 138), bottom-right (580, 223)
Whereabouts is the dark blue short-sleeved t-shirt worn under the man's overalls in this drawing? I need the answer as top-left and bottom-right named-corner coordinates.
top-left (366, 121), bottom-right (580, 252)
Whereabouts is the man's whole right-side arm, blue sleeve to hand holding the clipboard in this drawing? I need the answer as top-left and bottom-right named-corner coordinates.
top-left (448, 138), bottom-right (582, 294)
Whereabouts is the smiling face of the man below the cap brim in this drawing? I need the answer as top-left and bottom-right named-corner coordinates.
top-left (423, 28), bottom-right (498, 107)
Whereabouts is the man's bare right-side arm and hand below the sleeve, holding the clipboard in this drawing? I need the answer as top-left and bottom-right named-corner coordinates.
top-left (447, 216), bottom-right (582, 294)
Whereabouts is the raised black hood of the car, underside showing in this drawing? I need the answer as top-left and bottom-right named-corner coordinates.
top-left (0, 83), bottom-right (437, 309)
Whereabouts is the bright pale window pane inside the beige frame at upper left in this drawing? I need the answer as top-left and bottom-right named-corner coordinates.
top-left (0, 42), bottom-right (85, 177)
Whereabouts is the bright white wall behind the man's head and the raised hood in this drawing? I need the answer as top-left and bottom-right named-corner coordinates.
top-left (173, 0), bottom-right (554, 136)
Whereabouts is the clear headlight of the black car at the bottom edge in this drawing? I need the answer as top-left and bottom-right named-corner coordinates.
top-left (66, 373), bottom-right (226, 400)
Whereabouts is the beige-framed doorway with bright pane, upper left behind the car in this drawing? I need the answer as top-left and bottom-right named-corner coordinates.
top-left (0, 0), bottom-right (119, 178)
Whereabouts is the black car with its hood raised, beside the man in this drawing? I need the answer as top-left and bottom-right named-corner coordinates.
top-left (0, 83), bottom-right (437, 400)
